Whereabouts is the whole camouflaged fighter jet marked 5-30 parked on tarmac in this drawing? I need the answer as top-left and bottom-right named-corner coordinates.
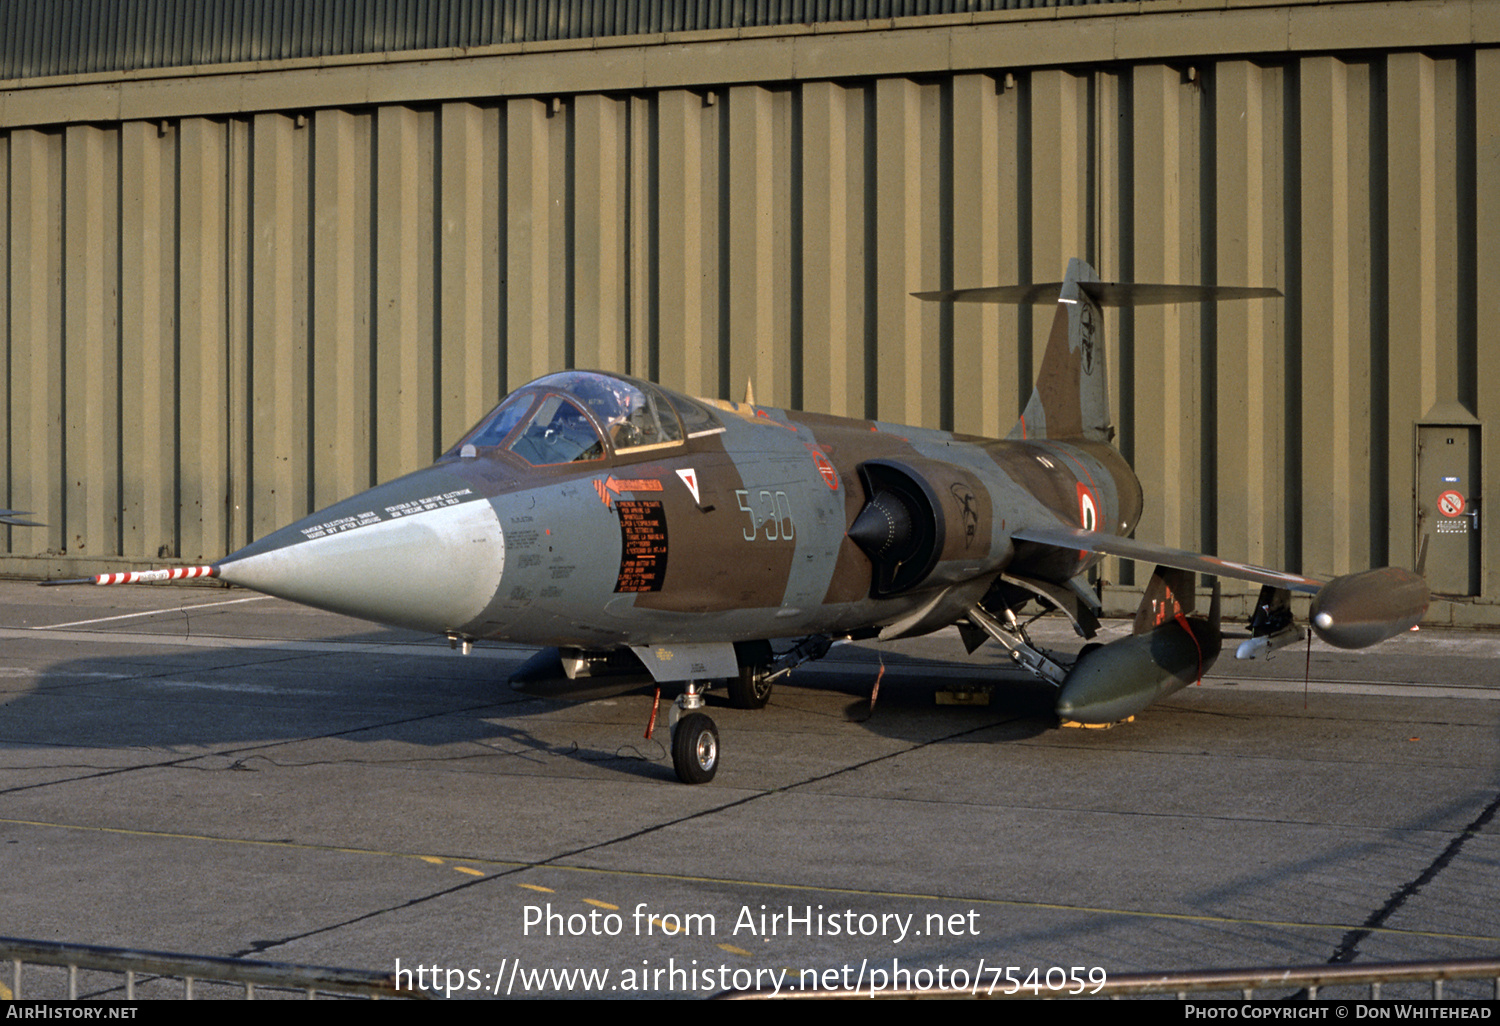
top-left (49, 260), bottom-right (1428, 783)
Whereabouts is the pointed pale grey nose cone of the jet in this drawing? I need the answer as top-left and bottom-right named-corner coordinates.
top-left (218, 467), bottom-right (506, 633)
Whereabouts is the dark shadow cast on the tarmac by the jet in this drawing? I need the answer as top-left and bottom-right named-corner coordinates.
top-left (0, 630), bottom-right (1056, 776)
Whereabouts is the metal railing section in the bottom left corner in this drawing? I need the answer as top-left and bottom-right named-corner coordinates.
top-left (0, 938), bottom-right (426, 1001)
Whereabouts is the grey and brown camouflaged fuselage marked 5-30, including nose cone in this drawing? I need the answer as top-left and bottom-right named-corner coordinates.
top-left (219, 375), bottom-right (1140, 650)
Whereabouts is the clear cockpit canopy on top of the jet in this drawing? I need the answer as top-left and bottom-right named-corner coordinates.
top-left (447, 371), bottom-right (722, 467)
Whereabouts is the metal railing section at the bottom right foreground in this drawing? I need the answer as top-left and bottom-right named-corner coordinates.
top-left (717, 959), bottom-right (1500, 1001)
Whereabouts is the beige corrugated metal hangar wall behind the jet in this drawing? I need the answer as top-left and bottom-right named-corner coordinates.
top-left (0, 0), bottom-right (1500, 623)
